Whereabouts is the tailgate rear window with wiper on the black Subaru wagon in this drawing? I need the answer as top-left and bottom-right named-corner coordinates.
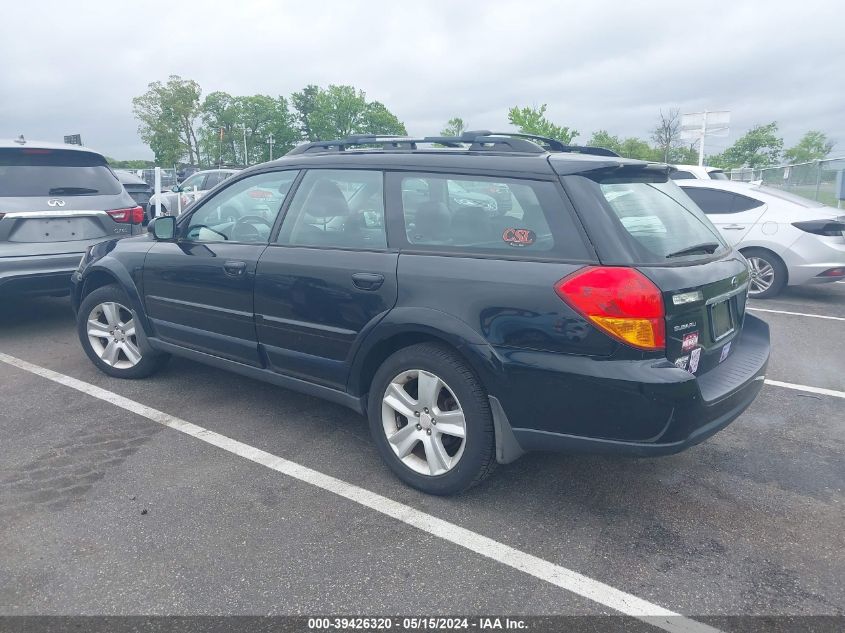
top-left (575, 169), bottom-right (727, 264)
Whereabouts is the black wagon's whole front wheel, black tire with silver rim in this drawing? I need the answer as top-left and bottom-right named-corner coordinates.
top-left (76, 285), bottom-right (169, 378)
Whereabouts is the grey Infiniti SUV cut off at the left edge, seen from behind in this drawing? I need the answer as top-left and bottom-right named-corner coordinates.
top-left (0, 137), bottom-right (144, 295)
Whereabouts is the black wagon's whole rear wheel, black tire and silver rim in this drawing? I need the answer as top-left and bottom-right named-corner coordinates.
top-left (368, 343), bottom-right (496, 495)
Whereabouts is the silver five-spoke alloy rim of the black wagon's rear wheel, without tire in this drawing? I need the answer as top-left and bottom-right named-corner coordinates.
top-left (382, 369), bottom-right (466, 476)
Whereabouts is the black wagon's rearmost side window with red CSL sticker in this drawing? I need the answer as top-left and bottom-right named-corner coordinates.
top-left (393, 173), bottom-right (590, 260)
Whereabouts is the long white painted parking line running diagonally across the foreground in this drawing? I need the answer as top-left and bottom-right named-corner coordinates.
top-left (0, 352), bottom-right (719, 633)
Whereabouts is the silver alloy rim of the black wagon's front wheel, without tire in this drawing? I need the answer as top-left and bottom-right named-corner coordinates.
top-left (86, 301), bottom-right (141, 369)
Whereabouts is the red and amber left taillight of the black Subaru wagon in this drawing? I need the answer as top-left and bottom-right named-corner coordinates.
top-left (555, 266), bottom-right (666, 350)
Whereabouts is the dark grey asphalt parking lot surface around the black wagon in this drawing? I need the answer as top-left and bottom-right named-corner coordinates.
top-left (0, 283), bottom-right (845, 619)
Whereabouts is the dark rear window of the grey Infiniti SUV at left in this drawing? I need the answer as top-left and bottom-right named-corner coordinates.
top-left (0, 147), bottom-right (123, 197)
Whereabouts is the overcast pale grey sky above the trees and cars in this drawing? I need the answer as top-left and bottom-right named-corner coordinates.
top-left (0, 0), bottom-right (845, 159)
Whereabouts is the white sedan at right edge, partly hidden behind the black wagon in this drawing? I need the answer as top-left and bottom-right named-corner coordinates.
top-left (678, 180), bottom-right (845, 299)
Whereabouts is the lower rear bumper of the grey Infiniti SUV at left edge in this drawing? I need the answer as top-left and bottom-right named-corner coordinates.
top-left (0, 252), bottom-right (84, 295)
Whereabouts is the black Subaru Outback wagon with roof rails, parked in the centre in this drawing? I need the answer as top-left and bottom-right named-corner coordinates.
top-left (72, 131), bottom-right (769, 494)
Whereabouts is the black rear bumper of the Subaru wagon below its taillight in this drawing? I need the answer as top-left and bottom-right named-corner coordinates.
top-left (492, 315), bottom-right (769, 456)
